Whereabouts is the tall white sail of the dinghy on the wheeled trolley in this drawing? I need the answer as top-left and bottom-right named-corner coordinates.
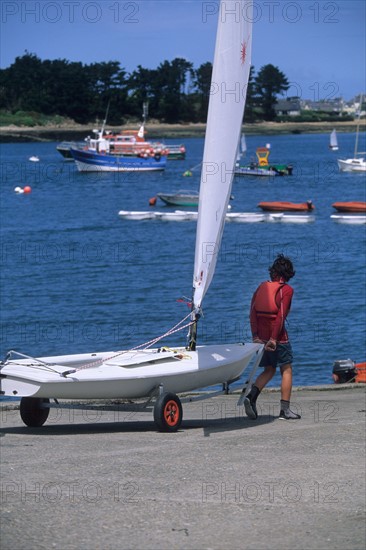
top-left (193, 0), bottom-right (253, 311)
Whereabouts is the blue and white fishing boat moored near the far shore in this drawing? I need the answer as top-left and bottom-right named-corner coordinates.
top-left (70, 131), bottom-right (167, 172)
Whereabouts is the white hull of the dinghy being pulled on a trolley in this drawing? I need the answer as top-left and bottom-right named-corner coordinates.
top-left (0, 344), bottom-right (263, 399)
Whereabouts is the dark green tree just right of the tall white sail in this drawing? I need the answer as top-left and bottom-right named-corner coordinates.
top-left (254, 64), bottom-right (289, 120)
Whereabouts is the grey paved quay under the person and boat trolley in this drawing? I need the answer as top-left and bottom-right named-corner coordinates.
top-left (0, 384), bottom-right (366, 550)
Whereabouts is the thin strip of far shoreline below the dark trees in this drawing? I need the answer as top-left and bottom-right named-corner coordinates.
top-left (0, 121), bottom-right (366, 143)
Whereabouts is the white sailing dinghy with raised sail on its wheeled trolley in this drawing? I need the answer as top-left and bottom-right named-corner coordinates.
top-left (0, 0), bottom-right (263, 431)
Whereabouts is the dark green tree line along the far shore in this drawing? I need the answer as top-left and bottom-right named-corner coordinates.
top-left (0, 52), bottom-right (289, 125)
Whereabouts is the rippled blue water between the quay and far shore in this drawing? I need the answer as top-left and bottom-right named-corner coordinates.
top-left (0, 134), bottom-right (366, 392)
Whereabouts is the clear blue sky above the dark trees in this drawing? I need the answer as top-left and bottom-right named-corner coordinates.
top-left (0, 0), bottom-right (366, 100)
